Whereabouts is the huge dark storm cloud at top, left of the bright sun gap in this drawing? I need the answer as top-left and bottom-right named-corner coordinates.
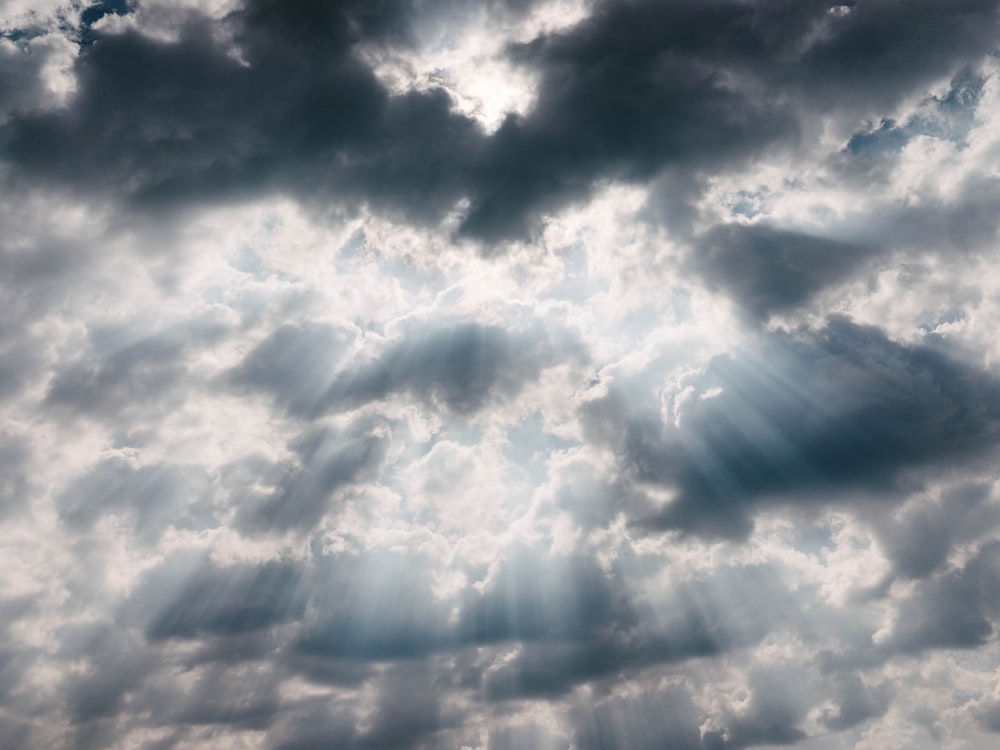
top-left (2, 0), bottom-right (481, 226)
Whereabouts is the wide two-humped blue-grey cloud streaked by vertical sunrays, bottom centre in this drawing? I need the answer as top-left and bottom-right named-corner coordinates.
top-left (296, 550), bottom-right (632, 668)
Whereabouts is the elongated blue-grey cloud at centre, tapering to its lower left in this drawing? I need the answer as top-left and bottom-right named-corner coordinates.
top-left (319, 323), bottom-right (582, 414)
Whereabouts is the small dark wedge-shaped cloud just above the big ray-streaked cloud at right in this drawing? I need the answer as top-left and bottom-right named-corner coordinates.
top-left (689, 224), bottom-right (870, 320)
